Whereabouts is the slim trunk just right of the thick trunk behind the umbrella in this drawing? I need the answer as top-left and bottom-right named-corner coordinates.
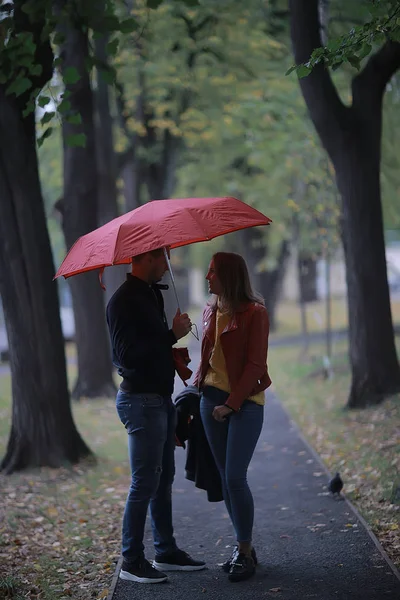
top-left (95, 30), bottom-right (129, 303)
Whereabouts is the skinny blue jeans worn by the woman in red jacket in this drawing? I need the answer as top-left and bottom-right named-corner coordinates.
top-left (200, 386), bottom-right (264, 542)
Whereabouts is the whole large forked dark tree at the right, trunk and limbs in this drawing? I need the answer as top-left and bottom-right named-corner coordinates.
top-left (290, 0), bottom-right (400, 407)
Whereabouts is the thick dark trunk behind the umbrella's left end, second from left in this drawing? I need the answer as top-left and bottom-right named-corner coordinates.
top-left (61, 5), bottom-right (115, 399)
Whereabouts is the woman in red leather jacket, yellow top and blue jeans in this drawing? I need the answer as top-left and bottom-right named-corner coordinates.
top-left (195, 252), bottom-right (271, 582)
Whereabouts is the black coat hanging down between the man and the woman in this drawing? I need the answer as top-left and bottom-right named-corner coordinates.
top-left (174, 385), bottom-right (223, 502)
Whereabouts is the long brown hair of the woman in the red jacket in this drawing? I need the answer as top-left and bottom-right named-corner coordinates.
top-left (211, 252), bottom-right (264, 314)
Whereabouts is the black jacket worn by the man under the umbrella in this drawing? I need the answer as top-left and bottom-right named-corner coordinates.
top-left (107, 274), bottom-right (177, 396)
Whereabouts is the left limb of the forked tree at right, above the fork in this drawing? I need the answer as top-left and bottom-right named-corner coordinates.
top-left (289, 0), bottom-right (347, 139)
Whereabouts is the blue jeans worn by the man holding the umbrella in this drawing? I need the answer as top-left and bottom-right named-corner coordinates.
top-left (117, 390), bottom-right (177, 562)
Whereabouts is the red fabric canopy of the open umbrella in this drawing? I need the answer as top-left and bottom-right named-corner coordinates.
top-left (55, 196), bottom-right (271, 278)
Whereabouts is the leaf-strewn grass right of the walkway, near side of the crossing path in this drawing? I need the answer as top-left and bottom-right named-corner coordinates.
top-left (269, 342), bottom-right (400, 567)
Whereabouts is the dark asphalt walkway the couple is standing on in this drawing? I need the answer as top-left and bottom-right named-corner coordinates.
top-left (109, 338), bottom-right (400, 600)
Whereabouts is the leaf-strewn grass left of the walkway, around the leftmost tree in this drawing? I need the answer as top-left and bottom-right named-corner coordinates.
top-left (0, 370), bottom-right (130, 600)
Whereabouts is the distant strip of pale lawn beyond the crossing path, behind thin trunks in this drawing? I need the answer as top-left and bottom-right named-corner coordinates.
top-left (271, 298), bottom-right (400, 339)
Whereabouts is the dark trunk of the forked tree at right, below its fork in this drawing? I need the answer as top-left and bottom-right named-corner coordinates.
top-left (336, 130), bottom-right (400, 408)
